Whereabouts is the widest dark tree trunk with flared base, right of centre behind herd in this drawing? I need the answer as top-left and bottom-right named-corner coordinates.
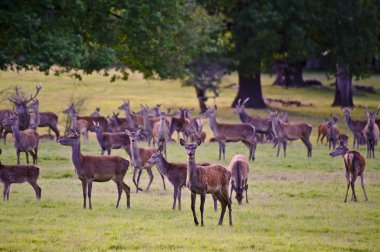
top-left (231, 71), bottom-right (266, 108)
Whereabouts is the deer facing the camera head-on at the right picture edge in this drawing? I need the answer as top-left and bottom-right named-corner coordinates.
top-left (363, 105), bottom-right (380, 158)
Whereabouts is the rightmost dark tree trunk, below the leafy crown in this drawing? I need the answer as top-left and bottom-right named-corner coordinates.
top-left (332, 65), bottom-right (354, 107)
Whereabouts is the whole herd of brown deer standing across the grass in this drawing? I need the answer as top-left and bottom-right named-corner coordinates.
top-left (0, 85), bottom-right (380, 225)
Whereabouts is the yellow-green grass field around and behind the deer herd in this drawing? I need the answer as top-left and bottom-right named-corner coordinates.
top-left (0, 72), bottom-right (380, 251)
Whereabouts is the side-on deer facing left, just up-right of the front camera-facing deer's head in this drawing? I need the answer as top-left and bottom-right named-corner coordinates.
top-left (201, 105), bottom-right (256, 160)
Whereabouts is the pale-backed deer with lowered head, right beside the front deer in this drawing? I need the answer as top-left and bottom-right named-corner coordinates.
top-left (227, 154), bottom-right (249, 205)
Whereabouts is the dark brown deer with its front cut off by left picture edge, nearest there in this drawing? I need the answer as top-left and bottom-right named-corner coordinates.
top-left (0, 149), bottom-right (41, 201)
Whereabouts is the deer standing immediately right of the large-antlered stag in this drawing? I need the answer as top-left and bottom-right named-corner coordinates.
top-left (28, 99), bottom-right (59, 141)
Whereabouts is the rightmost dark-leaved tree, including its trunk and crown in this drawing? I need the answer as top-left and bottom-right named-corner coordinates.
top-left (319, 0), bottom-right (380, 107)
